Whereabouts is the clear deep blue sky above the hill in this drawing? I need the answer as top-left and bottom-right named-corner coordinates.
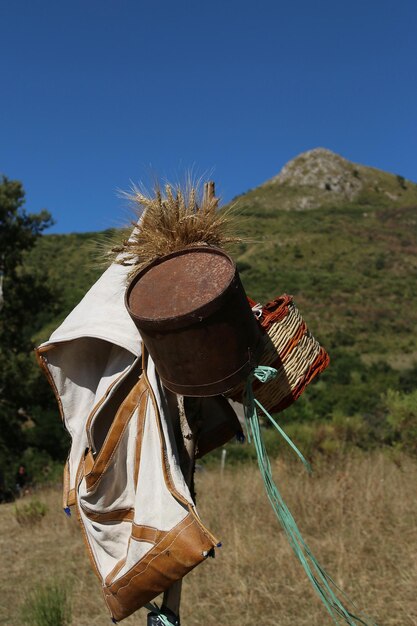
top-left (0, 0), bottom-right (417, 232)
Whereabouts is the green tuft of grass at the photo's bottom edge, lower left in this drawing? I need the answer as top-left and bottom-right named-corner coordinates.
top-left (22, 582), bottom-right (72, 626)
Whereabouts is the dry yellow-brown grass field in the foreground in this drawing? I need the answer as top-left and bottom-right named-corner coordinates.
top-left (0, 453), bottom-right (417, 626)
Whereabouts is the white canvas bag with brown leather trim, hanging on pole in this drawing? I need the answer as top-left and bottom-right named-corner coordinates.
top-left (37, 264), bottom-right (218, 620)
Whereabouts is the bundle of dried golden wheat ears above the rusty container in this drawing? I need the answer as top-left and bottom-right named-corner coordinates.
top-left (110, 182), bottom-right (241, 275)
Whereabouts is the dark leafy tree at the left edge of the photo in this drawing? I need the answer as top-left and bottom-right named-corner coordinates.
top-left (0, 176), bottom-right (53, 478)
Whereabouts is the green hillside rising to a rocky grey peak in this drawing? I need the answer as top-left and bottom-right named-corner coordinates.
top-left (4, 151), bottom-right (417, 486)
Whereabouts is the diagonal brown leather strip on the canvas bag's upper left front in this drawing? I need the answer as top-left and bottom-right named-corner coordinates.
top-left (85, 377), bottom-right (147, 491)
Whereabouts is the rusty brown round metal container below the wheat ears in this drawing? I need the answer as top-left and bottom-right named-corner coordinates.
top-left (125, 246), bottom-right (262, 397)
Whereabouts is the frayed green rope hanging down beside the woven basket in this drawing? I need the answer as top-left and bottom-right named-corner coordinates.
top-left (244, 366), bottom-right (375, 626)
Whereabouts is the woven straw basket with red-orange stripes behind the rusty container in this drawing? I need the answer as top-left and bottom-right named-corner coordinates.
top-left (228, 294), bottom-right (330, 413)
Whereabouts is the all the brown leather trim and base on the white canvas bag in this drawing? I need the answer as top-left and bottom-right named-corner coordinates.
top-left (76, 348), bottom-right (217, 620)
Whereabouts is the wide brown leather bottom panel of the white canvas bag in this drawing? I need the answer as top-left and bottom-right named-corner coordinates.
top-left (103, 513), bottom-right (215, 620)
